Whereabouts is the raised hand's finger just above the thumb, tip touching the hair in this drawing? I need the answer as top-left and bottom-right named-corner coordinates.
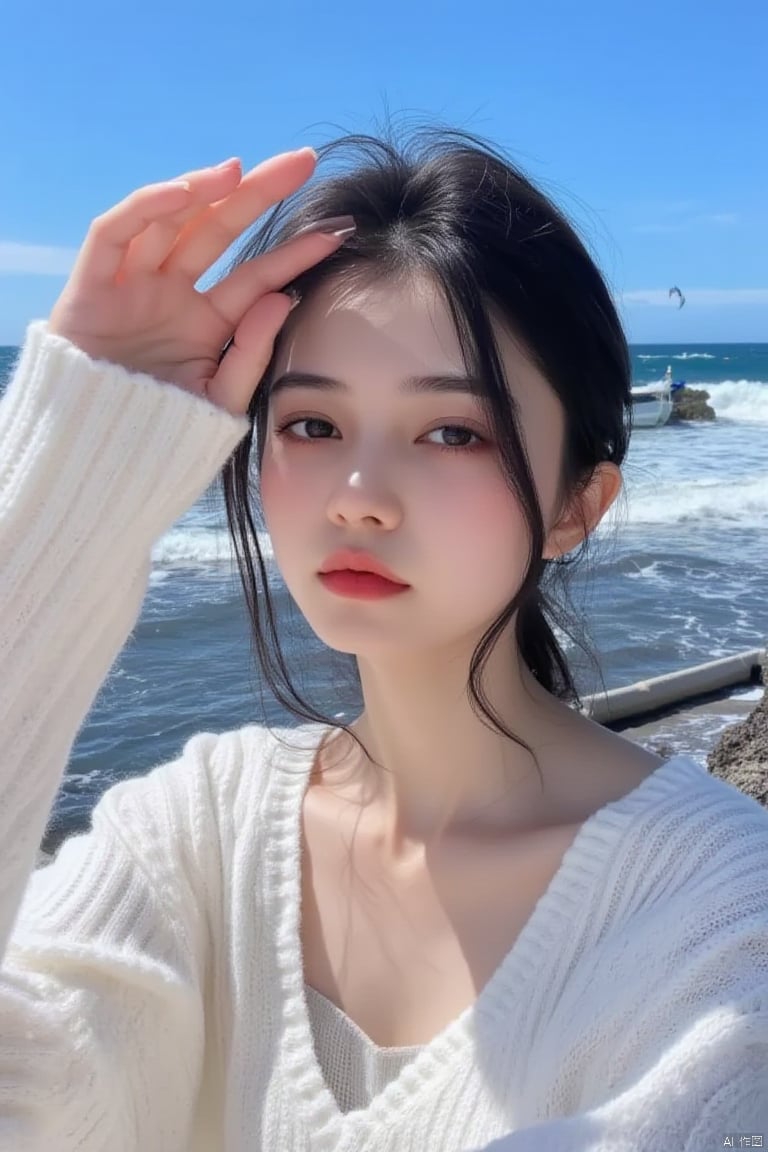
top-left (204, 217), bottom-right (353, 327)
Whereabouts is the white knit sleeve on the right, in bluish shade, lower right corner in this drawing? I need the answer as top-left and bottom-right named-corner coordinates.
top-left (474, 811), bottom-right (768, 1152)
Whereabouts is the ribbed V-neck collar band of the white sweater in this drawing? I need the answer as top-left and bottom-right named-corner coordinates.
top-left (265, 723), bottom-right (706, 1152)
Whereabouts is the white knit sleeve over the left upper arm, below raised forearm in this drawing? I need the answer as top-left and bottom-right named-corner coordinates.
top-left (0, 734), bottom-right (221, 1152)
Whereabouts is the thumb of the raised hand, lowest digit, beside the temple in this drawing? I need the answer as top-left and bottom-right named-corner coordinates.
top-left (207, 293), bottom-right (294, 415)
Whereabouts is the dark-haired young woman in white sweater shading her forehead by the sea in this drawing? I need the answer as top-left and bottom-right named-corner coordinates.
top-left (0, 134), bottom-right (768, 1152)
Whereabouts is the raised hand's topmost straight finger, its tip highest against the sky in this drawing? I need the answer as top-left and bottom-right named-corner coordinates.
top-left (166, 149), bottom-right (317, 281)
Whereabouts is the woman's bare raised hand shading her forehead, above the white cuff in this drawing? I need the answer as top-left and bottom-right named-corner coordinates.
top-left (48, 149), bottom-right (344, 414)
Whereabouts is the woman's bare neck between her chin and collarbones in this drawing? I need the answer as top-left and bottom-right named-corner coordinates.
top-left (317, 638), bottom-right (570, 854)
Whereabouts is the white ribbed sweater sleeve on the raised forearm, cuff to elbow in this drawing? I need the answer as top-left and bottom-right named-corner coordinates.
top-left (0, 325), bottom-right (248, 955)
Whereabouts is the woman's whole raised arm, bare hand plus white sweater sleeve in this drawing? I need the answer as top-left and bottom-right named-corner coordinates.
top-left (0, 150), bottom-right (350, 1152)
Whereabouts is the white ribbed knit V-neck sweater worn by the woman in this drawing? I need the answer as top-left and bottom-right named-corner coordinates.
top-left (0, 325), bottom-right (768, 1152)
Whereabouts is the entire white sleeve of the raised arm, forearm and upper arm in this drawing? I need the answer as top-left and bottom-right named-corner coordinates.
top-left (0, 324), bottom-right (248, 1152)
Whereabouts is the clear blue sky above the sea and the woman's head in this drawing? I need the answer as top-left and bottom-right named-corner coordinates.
top-left (0, 0), bottom-right (768, 343)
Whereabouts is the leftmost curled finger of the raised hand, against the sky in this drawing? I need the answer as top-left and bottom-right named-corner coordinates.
top-left (73, 180), bottom-right (195, 286)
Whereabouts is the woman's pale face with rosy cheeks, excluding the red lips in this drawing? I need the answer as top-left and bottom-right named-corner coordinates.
top-left (261, 273), bottom-right (564, 658)
